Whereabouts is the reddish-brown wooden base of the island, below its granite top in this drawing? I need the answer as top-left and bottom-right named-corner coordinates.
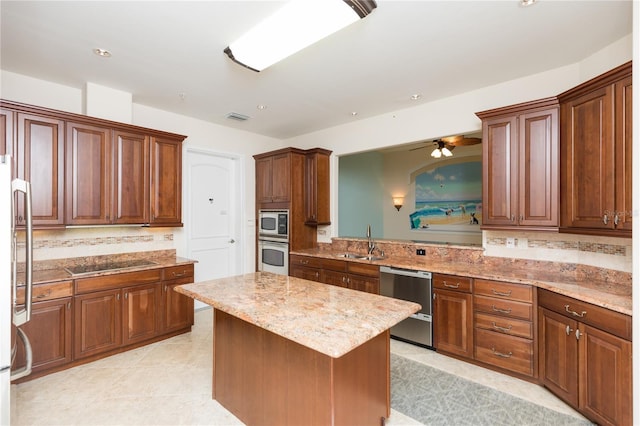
top-left (213, 310), bottom-right (390, 426)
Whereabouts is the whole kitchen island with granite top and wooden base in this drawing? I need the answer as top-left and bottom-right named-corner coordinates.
top-left (176, 272), bottom-right (420, 425)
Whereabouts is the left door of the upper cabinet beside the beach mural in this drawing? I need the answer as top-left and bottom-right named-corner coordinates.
top-left (482, 116), bottom-right (518, 226)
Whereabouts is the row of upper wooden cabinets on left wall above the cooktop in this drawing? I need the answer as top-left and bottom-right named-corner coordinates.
top-left (0, 101), bottom-right (185, 228)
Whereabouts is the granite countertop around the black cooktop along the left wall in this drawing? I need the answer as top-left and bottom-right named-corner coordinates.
top-left (17, 251), bottom-right (196, 286)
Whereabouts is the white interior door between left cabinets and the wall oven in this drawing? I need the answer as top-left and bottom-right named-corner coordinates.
top-left (185, 150), bottom-right (242, 307)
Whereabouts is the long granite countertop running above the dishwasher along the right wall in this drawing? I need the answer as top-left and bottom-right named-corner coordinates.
top-left (291, 249), bottom-right (633, 315)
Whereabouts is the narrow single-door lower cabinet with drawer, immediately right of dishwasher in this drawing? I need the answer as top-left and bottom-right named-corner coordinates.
top-left (433, 274), bottom-right (473, 358)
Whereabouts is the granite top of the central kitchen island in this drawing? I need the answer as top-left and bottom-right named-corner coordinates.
top-left (176, 272), bottom-right (420, 358)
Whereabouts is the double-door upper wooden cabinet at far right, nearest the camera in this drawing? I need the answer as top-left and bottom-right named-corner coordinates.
top-left (558, 62), bottom-right (632, 237)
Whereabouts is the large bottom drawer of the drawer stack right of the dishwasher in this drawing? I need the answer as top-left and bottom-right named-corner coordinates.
top-left (475, 328), bottom-right (534, 376)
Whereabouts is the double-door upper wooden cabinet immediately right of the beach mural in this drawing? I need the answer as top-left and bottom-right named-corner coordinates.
top-left (477, 98), bottom-right (559, 230)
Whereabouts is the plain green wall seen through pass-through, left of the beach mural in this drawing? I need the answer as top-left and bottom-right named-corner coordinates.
top-left (338, 152), bottom-right (384, 238)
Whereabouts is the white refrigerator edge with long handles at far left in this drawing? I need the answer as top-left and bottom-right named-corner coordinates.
top-left (0, 155), bottom-right (33, 425)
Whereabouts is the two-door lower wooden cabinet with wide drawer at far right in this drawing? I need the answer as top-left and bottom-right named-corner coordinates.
top-left (538, 289), bottom-right (632, 425)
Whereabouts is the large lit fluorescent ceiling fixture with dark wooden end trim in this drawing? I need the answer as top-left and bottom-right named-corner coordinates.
top-left (224, 0), bottom-right (377, 71)
